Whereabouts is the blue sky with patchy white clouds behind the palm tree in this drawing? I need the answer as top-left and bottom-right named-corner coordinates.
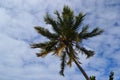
top-left (0, 0), bottom-right (120, 80)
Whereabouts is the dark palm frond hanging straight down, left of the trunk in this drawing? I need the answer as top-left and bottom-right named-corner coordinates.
top-left (59, 52), bottom-right (67, 76)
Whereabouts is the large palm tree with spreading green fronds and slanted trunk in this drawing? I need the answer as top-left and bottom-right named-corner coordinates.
top-left (31, 6), bottom-right (103, 80)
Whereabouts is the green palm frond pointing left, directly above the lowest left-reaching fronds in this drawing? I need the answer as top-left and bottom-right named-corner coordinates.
top-left (35, 26), bottom-right (58, 39)
